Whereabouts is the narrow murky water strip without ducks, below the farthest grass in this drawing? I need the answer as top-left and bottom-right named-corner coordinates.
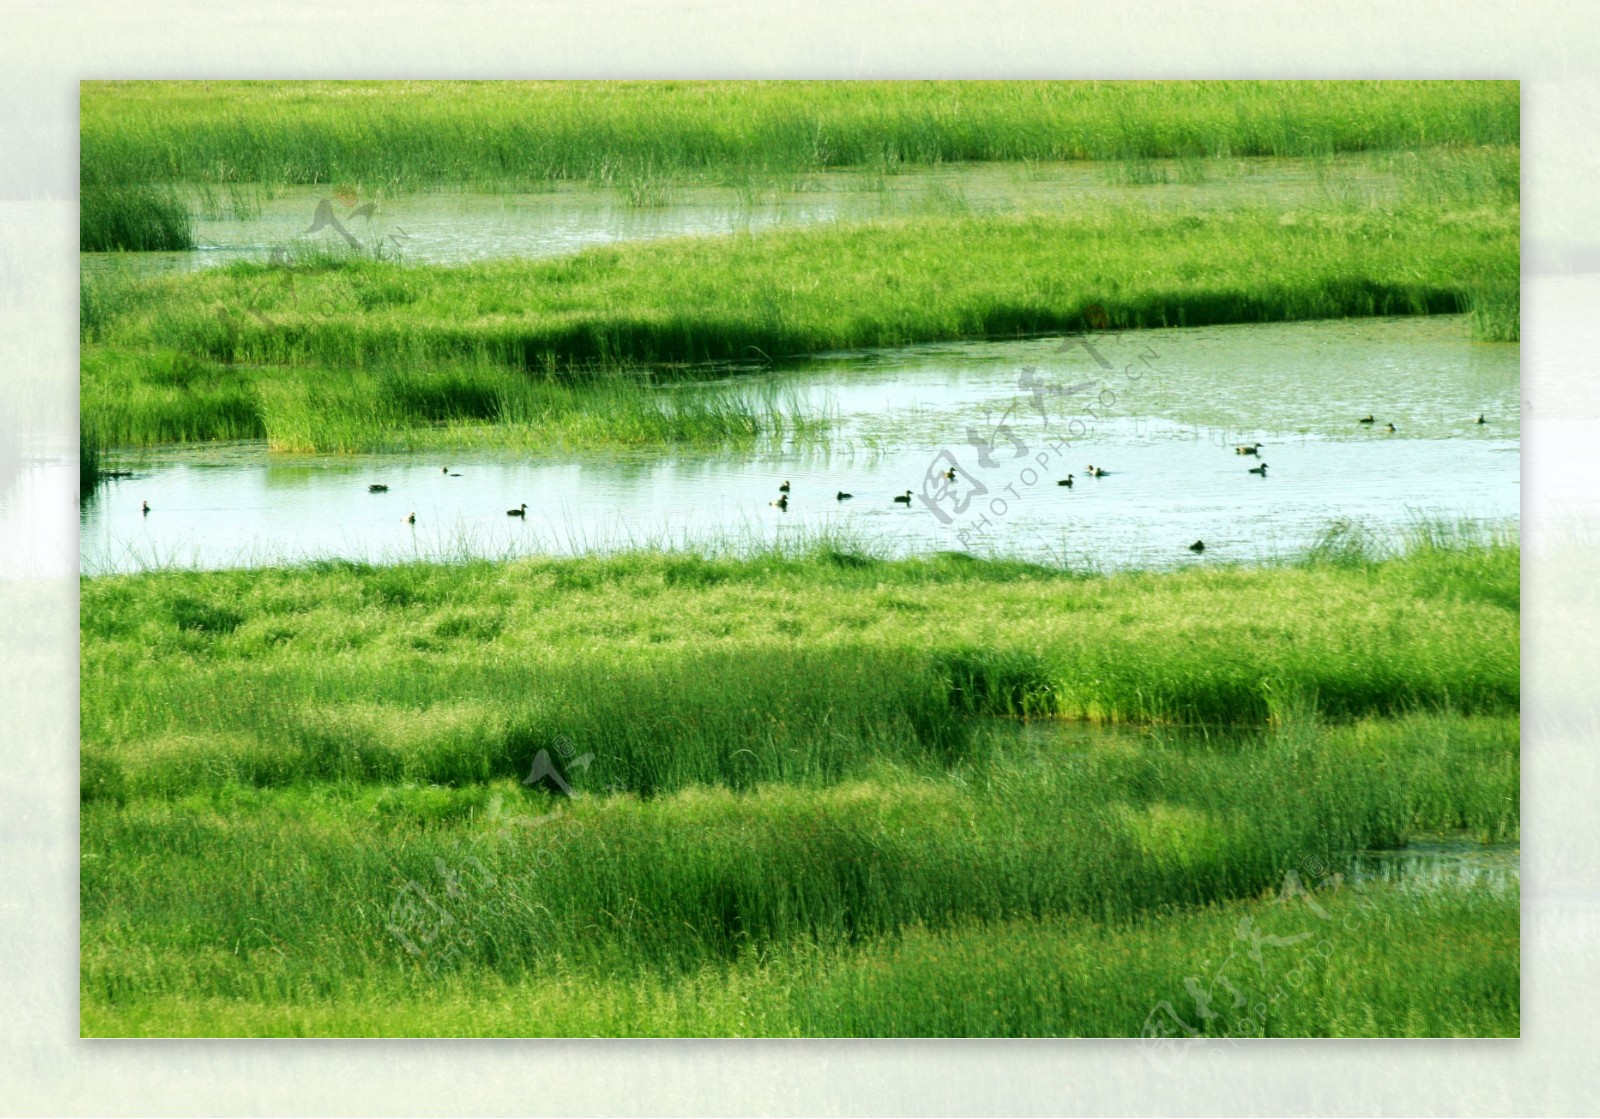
top-left (82, 155), bottom-right (1398, 274)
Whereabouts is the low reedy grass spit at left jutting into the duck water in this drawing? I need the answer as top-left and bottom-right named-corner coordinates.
top-left (80, 346), bottom-right (830, 453)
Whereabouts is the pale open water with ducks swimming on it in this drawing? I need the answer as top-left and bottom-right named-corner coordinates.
top-left (80, 317), bottom-right (1520, 572)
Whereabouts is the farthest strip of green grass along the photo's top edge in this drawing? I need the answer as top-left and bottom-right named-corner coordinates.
top-left (80, 82), bottom-right (1520, 191)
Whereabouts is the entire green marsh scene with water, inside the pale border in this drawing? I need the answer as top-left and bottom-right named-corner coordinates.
top-left (78, 83), bottom-right (1520, 1043)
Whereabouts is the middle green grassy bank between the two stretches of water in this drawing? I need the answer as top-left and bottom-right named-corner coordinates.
top-left (82, 191), bottom-right (1518, 450)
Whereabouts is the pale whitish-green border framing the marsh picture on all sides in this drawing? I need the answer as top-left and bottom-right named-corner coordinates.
top-left (0, 0), bottom-right (1600, 1114)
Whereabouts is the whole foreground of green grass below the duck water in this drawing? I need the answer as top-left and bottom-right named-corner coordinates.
top-left (80, 535), bottom-right (1520, 1034)
